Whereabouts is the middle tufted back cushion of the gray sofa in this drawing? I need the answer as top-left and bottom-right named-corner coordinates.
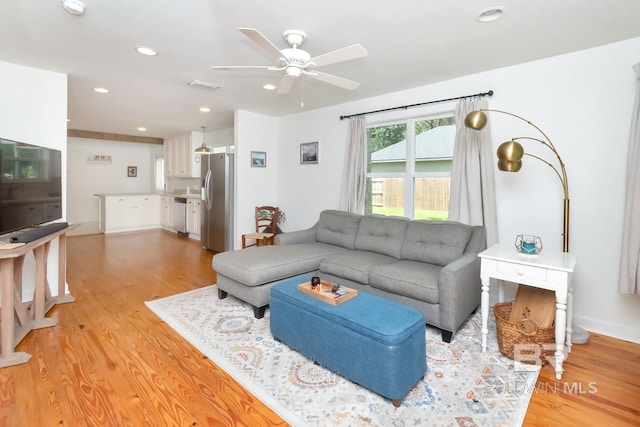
top-left (356, 216), bottom-right (409, 258)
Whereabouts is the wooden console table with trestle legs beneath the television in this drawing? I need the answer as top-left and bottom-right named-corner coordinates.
top-left (0, 224), bottom-right (77, 368)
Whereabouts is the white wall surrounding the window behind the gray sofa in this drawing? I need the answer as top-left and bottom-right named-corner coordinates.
top-left (258, 38), bottom-right (640, 342)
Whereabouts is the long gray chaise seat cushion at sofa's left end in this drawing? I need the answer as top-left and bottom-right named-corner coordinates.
top-left (212, 243), bottom-right (347, 286)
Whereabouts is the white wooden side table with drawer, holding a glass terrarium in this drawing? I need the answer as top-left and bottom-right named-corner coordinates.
top-left (478, 243), bottom-right (577, 380)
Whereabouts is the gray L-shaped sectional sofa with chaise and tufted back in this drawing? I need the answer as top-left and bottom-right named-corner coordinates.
top-left (212, 210), bottom-right (485, 342)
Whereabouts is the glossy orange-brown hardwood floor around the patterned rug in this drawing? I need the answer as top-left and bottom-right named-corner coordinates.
top-left (0, 230), bottom-right (640, 427)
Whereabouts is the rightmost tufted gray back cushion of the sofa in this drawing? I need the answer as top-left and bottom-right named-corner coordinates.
top-left (400, 220), bottom-right (472, 266)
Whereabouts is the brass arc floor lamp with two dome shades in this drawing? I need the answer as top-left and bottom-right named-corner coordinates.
top-left (464, 109), bottom-right (569, 252)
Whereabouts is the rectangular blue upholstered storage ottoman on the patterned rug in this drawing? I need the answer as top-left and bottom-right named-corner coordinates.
top-left (269, 277), bottom-right (427, 406)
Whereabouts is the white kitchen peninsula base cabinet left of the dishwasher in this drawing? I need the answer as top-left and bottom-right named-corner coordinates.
top-left (104, 194), bottom-right (160, 233)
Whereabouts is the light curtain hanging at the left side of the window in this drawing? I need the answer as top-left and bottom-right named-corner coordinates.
top-left (339, 116), bottom-right (367, 213)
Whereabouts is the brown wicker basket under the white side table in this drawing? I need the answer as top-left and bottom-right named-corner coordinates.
top-left (493, 302), bottom-right (556, 365)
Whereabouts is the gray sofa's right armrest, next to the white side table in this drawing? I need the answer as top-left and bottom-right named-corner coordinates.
top-left (438, 253), bottom-right (481, 331)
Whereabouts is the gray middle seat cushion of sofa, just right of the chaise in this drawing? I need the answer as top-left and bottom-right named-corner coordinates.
top-left (320, 250), bottom-right (397, 285)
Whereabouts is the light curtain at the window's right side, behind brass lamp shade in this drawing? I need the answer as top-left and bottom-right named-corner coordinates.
top-left (449, 99), bottom-right (498, 247)
